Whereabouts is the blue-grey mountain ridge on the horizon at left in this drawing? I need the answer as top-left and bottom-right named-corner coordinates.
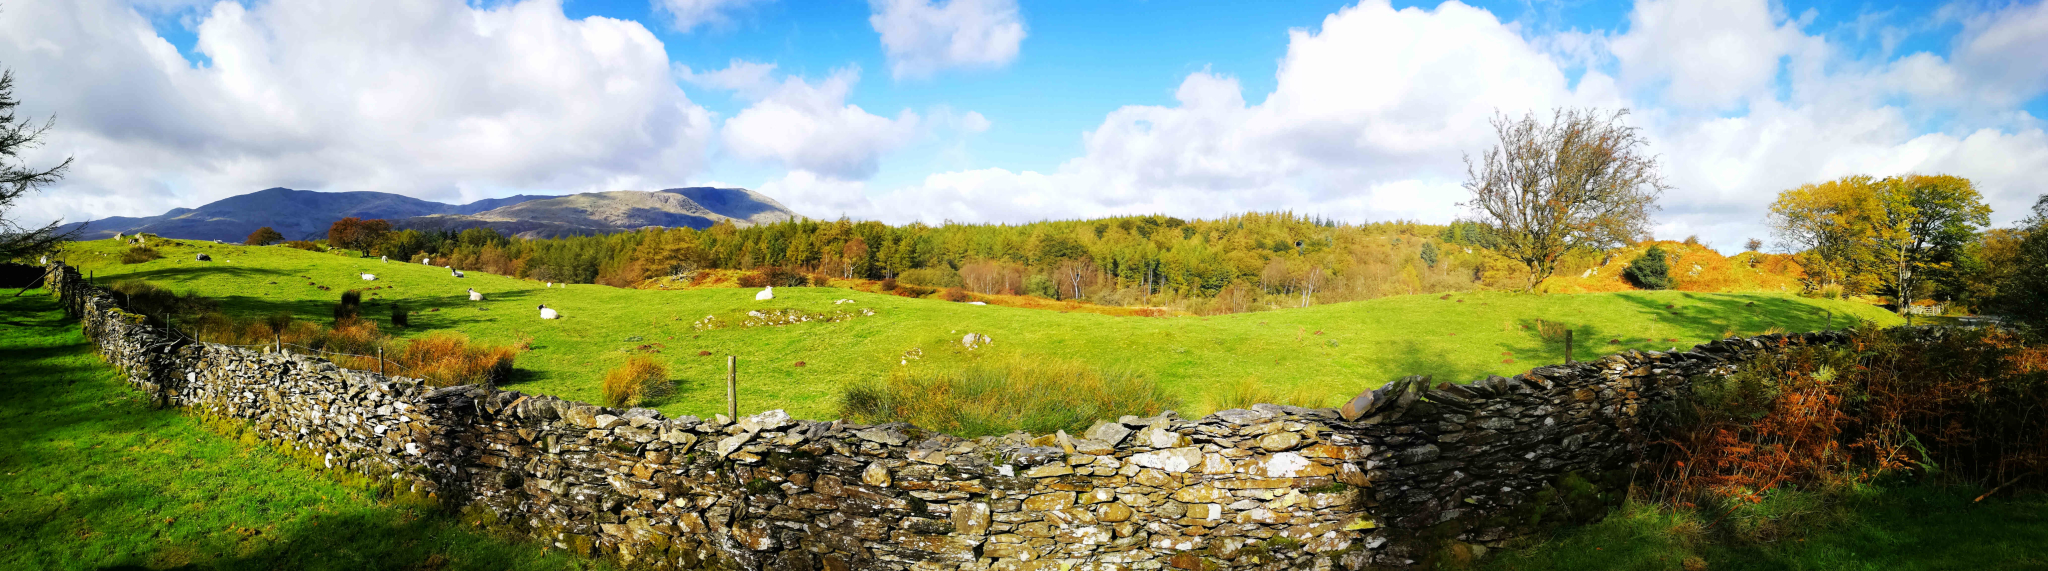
top-left (63, 186), bottom-right (797, 241)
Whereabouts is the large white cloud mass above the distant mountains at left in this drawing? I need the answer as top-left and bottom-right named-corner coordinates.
top-left (0, 0), bottom-right (713, 228)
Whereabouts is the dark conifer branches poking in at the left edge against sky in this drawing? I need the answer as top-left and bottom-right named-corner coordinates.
top-left (0, 70), bottom-right (84, 260)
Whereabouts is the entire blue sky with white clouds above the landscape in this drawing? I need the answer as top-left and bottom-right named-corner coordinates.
top-left (0, 0), bottom-right (2048, 248)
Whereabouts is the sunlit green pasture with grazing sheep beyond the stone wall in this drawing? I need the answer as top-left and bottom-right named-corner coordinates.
top-left (51, 239), bottom-right (1898, 418)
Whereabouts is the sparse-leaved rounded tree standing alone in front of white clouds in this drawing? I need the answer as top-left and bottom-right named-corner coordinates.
top-left (1462, 108), bottom-right (1671, 291)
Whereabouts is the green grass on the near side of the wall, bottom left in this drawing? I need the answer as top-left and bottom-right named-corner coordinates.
top-left (0, 291), bottom-right (600, 571)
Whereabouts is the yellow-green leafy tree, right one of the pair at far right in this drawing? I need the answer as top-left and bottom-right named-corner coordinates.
top-left (1874, 174), bottom-right (1991, 313)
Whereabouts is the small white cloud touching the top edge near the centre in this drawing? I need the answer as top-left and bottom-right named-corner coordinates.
top-left (868, 0), bottom-right (1024, 78)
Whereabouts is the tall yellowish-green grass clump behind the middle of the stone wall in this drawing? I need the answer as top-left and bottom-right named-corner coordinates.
top-left (840, 356), bottom-right (1180, 438)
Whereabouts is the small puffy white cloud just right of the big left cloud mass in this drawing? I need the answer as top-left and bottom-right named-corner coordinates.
top-left (713, 61), bottom-right (920, 180)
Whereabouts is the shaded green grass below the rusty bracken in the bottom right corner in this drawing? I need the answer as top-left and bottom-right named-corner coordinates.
top-left (1481, 487), bottom-right (2048, 571)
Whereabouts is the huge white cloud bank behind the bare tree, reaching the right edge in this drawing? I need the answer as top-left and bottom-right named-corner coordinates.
top-left (872, 0), bottom-right (2048, 248)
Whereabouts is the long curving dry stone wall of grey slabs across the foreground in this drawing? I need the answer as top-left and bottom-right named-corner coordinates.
top-left (53, 266), bottom-right (1837, 571)
